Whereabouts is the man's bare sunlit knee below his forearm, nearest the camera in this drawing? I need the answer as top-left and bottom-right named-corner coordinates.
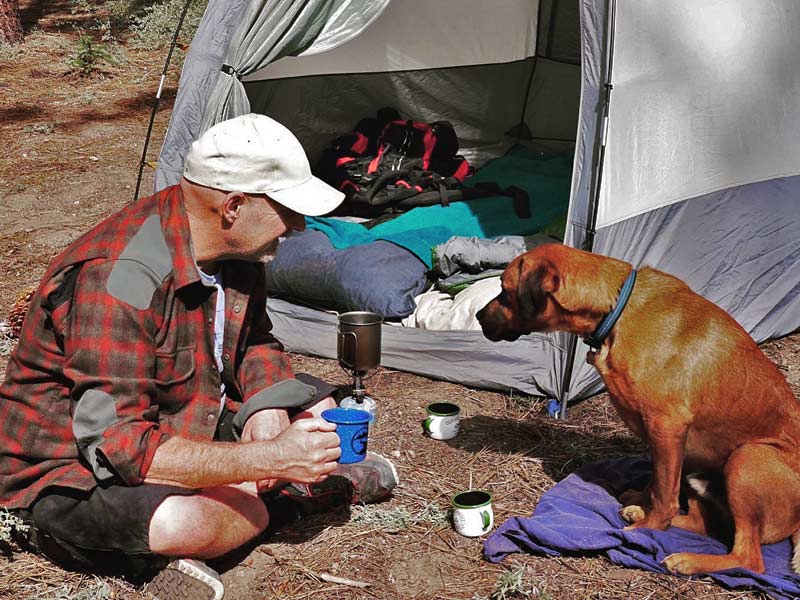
top-left (149, 486), bottom-right (269, 558)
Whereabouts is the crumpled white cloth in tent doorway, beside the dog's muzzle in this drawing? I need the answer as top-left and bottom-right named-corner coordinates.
top-left (402, 277), bottom-right (500, 331)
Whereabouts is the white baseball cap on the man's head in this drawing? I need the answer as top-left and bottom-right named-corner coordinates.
top-left (183, 113), bottom-right (344, 217)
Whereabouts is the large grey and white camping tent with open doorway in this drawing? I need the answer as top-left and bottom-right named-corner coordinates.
top-left (156, 0), bottom-right (800, 415)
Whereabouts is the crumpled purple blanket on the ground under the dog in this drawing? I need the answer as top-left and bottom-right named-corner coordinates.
top-left (483, 457), bottom-right (800, 600)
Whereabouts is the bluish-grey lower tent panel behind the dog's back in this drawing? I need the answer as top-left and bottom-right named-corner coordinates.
top-left (570, 177), bottom-right (800, 404)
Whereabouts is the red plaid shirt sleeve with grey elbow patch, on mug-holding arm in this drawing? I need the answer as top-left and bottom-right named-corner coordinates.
top-left (64, 261), bottom-right (167, 485)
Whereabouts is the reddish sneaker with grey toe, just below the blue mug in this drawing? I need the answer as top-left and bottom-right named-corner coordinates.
top-left (281, 452), bottom-right (399, 514)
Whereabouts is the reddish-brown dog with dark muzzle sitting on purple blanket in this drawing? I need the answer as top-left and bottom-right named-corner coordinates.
top-left (478, 244), bottom-right (800, 575)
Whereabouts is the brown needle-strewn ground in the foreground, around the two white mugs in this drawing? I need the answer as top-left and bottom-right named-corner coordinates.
top-left (0, 350), bottom-right (788, 600)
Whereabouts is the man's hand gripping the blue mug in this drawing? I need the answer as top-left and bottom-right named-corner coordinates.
top-left (270, 417), bottom-right (342, 483)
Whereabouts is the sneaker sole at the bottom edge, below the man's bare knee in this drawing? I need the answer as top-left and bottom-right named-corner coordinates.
top-left (144, 558), bottom-right (225, 600)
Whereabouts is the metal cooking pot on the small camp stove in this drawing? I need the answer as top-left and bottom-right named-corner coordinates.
top-left (336, 311), bottom-right (383, 373)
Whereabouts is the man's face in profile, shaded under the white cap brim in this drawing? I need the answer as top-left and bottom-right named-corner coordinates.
top-left (229, 195), bottom-right (305, 262)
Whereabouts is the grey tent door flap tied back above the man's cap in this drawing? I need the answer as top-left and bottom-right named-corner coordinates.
top-left (155, 0), bottom-right (388, 190)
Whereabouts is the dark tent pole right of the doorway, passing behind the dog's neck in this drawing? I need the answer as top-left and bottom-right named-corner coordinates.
top-left (558, 0), bottom-right (617, 419)
